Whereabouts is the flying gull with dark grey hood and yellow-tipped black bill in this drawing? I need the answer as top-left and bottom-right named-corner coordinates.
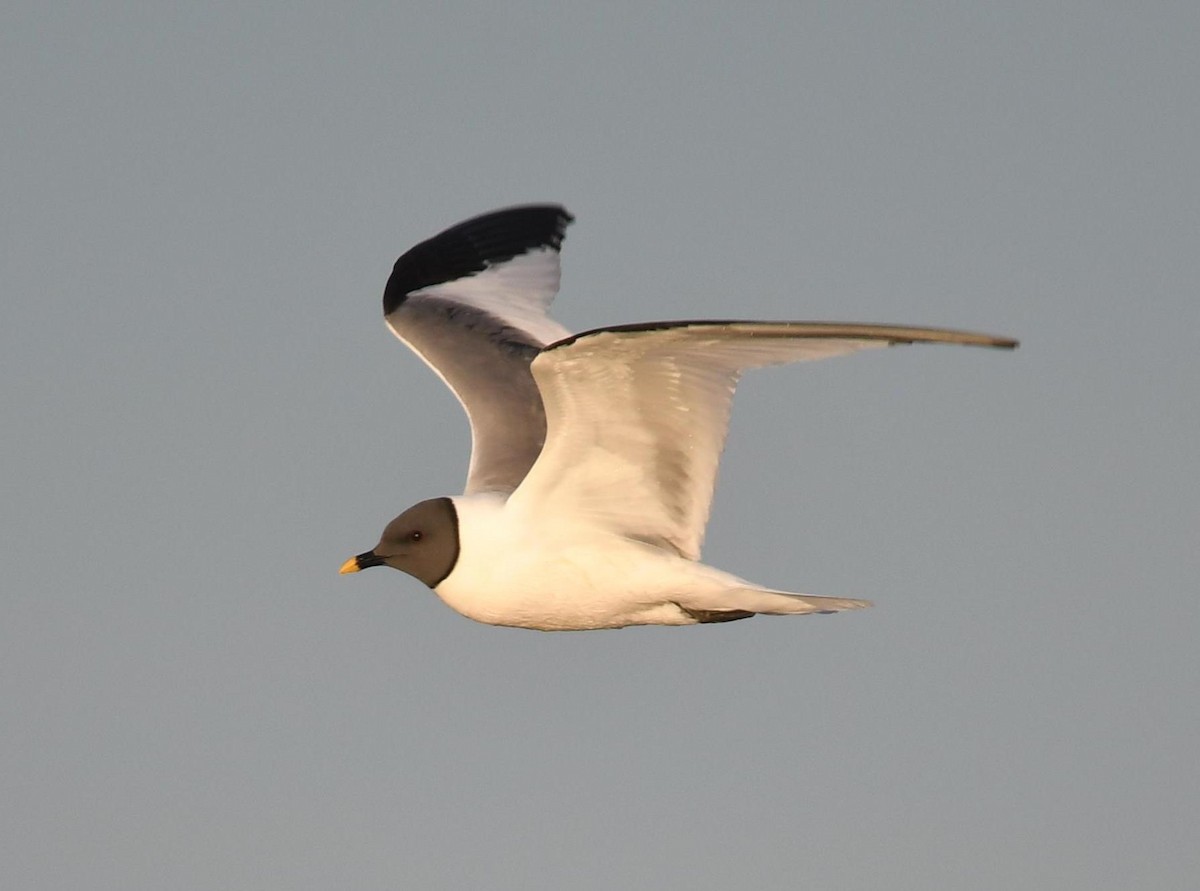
top-left (341, 204), bottom-right (1016, 630)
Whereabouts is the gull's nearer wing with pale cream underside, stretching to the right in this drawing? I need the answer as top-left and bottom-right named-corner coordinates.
top-left (509, 322), bottom-right (1016, 560)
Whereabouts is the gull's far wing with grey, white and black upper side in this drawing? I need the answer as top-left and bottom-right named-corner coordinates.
top-left (383, 204), bottom-right (572, 495)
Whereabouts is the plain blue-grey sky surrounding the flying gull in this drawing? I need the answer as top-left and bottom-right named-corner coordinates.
top-left (0, 2), bottom-right (1200, 891)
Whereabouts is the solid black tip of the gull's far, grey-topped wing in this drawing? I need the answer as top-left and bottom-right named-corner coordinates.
top-left (383, 204), bottom-right (575, 316)
